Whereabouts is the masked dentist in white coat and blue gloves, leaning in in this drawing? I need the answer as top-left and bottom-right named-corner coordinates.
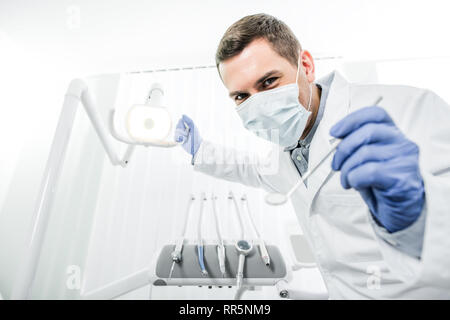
top-left (175, 14), bottom-right (450, 299)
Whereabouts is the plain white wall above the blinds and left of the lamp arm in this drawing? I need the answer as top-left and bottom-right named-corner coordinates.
top-left (0, 0), bottom-right (450, 297)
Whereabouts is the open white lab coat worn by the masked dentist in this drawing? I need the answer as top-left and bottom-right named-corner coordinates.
top-left (194, 72), bottom-right (450, 299)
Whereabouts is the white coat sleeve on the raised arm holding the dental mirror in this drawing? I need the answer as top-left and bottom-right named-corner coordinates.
top-left (377, 92), bottom-right (450, 289)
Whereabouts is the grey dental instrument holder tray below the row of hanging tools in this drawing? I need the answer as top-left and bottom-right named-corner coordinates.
top-left (153, 241), bottom-right (287, 286)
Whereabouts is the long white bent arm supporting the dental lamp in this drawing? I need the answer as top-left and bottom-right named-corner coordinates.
top-left (11, 79), bottom-right (134, 299)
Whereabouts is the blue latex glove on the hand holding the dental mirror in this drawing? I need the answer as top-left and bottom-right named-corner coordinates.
top-left (330, 106), bottom-right (425, 232)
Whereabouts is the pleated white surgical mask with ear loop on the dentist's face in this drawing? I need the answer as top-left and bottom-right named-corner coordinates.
top-left (236, 57), bottom-right (312, 147)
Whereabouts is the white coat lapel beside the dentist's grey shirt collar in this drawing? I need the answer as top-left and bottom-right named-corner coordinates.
top-left (306, 71), bottom-right (350, 206)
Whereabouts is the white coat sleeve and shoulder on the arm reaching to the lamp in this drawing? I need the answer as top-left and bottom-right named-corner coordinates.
top-left (193, 140), bottom-right (299, 192)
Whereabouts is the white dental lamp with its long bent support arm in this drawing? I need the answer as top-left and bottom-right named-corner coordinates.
top-left (11, 79), bottom-right (179, 299)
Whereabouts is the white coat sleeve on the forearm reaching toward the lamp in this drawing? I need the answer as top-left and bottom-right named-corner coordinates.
top-left (192, 140), bottom-right (275, 192)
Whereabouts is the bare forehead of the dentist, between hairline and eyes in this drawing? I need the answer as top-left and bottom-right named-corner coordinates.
top-left (219, 39), bottom-right (293, 92)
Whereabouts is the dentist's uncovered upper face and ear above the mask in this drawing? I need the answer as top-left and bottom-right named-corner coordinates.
top-left (219, 39), bottom-right (308, 105)
